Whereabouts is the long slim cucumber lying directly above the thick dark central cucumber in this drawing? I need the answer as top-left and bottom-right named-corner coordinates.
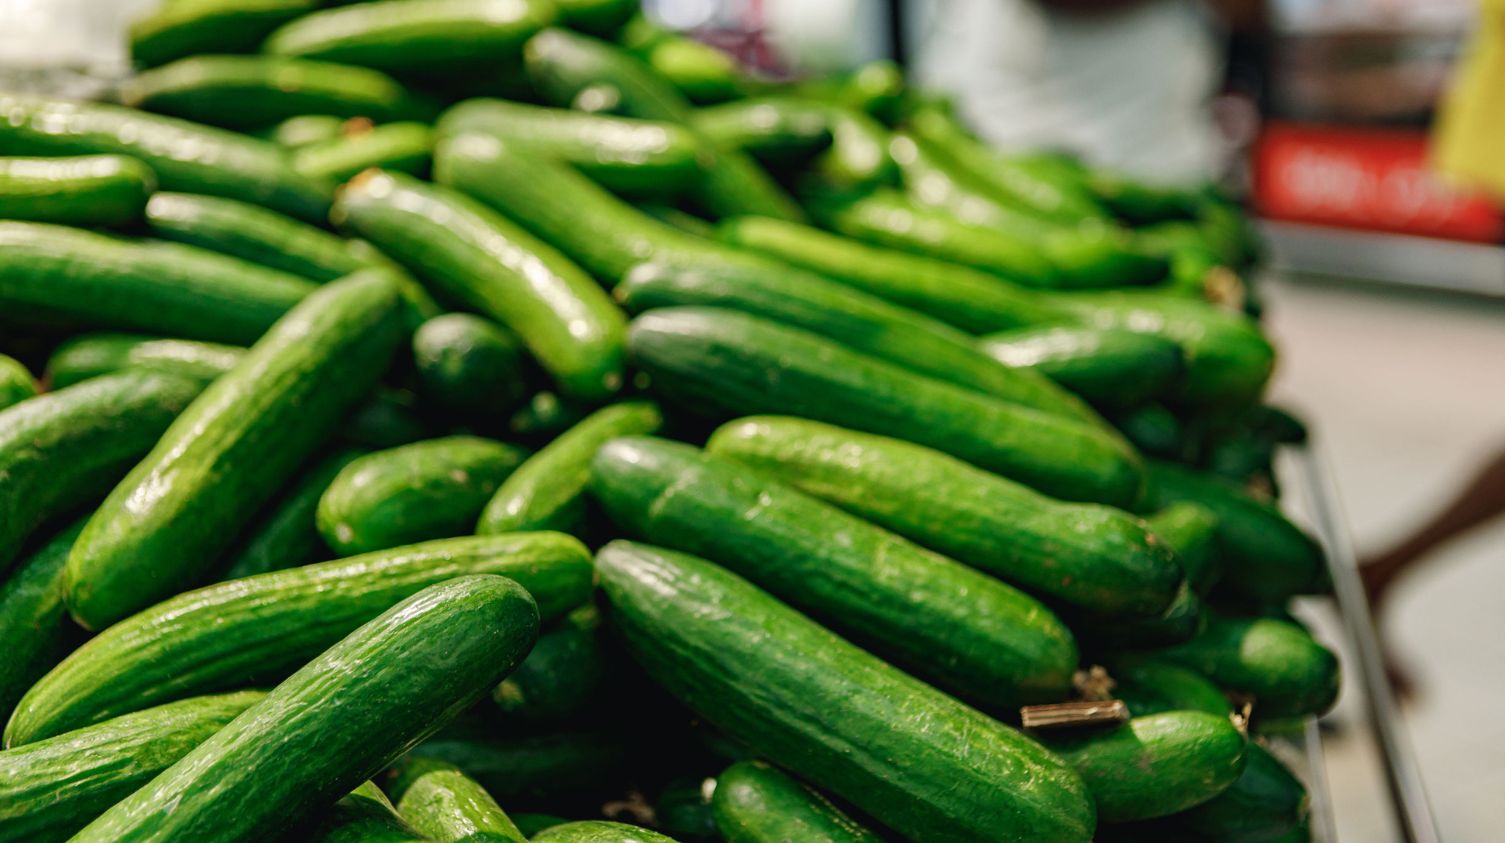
top-left (614, 260), bottom-right (1106, 428)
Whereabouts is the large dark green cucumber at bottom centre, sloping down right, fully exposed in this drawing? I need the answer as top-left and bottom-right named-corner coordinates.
top-left (596, 542), bottom-right (1094, 843)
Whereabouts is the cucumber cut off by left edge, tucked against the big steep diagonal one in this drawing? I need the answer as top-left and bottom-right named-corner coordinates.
top-left (0, 372), bottom-right (203, 572)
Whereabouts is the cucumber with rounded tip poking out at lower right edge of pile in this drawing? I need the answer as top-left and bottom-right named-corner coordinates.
top-left (1157, 613), bottom-right (1338, 718)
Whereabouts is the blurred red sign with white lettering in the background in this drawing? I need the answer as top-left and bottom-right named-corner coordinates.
top-left (1254, 123), bottom-right (1505, 242)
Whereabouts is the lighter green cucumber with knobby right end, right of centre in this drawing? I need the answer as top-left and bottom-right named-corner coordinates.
top-left (706, 415), bottom-right (1181, 616)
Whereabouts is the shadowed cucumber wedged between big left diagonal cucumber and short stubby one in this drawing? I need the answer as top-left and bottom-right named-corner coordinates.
top-left (223, 449), bottom-right (366, 580)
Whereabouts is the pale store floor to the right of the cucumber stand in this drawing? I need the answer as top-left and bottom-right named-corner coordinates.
top-left (1267, 278), bottom-right (1505, 843)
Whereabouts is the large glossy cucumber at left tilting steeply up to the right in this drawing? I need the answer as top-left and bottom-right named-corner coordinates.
top-left (68, 275), bottom-right (402, 629)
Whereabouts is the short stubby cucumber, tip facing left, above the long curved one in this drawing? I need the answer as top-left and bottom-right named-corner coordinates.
top-left (318, 437), bottom-right (524, 554)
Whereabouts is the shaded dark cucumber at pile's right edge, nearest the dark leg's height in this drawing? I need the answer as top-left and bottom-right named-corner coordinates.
top-left (1150, 461), bottom-right (1327, 599)
